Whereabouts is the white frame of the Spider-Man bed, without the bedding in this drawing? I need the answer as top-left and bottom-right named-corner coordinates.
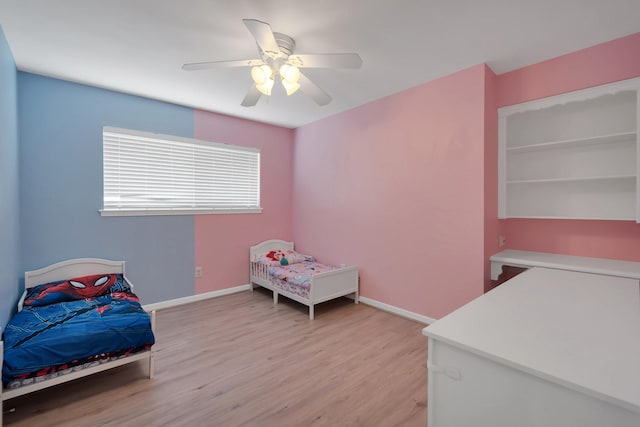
top-left (0, 258), bottom-right (156, 427)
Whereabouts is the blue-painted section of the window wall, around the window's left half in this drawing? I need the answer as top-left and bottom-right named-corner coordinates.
top-left (18, 72), bottom-right (195, 304)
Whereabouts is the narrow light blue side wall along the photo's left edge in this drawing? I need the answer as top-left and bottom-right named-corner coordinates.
top-left (0, 27), bottom-right (20, 329)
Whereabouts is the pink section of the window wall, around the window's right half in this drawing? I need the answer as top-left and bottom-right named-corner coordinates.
top-left (194, 110), bottom-right (294, 294)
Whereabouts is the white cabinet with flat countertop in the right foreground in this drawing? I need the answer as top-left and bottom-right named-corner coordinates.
top-left (423, 268), bottom-right (640, 427)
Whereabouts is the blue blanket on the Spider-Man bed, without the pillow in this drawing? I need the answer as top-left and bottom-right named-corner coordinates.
top-left (2, 292), bottom-right (155, 385)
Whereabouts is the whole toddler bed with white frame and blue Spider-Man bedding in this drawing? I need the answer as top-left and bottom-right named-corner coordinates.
top-left (0, 258), bottom-right (155, 426)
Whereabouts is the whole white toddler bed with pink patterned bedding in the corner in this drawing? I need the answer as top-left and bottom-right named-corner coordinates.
top-left (249, 240), bottom-right (358, 320)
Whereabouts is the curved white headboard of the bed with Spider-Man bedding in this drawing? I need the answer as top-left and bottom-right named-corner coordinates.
top-left (24, 258), bottom-right (124, 288)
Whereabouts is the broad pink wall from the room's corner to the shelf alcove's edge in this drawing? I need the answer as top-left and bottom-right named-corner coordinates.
top-left (293, 65), bottom-right (486, 318)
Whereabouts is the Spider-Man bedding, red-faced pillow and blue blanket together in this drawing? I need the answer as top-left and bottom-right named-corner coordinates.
top-left (2, 274), bottom-right (155, 386)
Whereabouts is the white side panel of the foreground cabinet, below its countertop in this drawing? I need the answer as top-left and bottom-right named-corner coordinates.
top-left (429, 339), bottom-right (640, 427)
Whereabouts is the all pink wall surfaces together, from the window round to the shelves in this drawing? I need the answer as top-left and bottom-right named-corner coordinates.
top-left (195, 33), bottom-right (640, 318)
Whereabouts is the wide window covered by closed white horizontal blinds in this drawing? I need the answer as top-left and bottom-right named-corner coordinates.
top-left (100, 127), bottom-right (262, 216)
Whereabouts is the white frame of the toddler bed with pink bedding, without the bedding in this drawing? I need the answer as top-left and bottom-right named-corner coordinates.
top-left (249, 240), bottom-right (358, 320)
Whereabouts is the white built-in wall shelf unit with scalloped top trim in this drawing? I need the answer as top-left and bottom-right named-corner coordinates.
top-left (498, 78), bottom-right (640, 221)
